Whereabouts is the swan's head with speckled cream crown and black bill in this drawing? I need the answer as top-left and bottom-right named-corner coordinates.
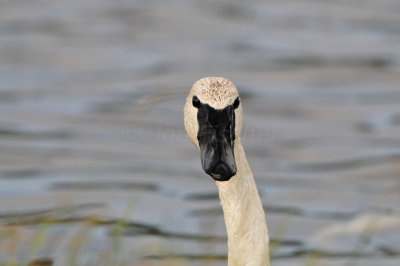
top-left (184, 77), bottom-right (242, 181)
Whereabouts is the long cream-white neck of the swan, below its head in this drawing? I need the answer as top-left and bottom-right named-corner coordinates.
top-left (217, 139), bottom-right (270, 266)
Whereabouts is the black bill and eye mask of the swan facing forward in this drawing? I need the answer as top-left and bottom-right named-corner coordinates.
top-left (193, 96), bottom-right (239, 181)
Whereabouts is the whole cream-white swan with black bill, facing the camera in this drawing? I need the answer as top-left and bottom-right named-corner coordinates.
top-left (184, 77), bottom-right (270, 266)
